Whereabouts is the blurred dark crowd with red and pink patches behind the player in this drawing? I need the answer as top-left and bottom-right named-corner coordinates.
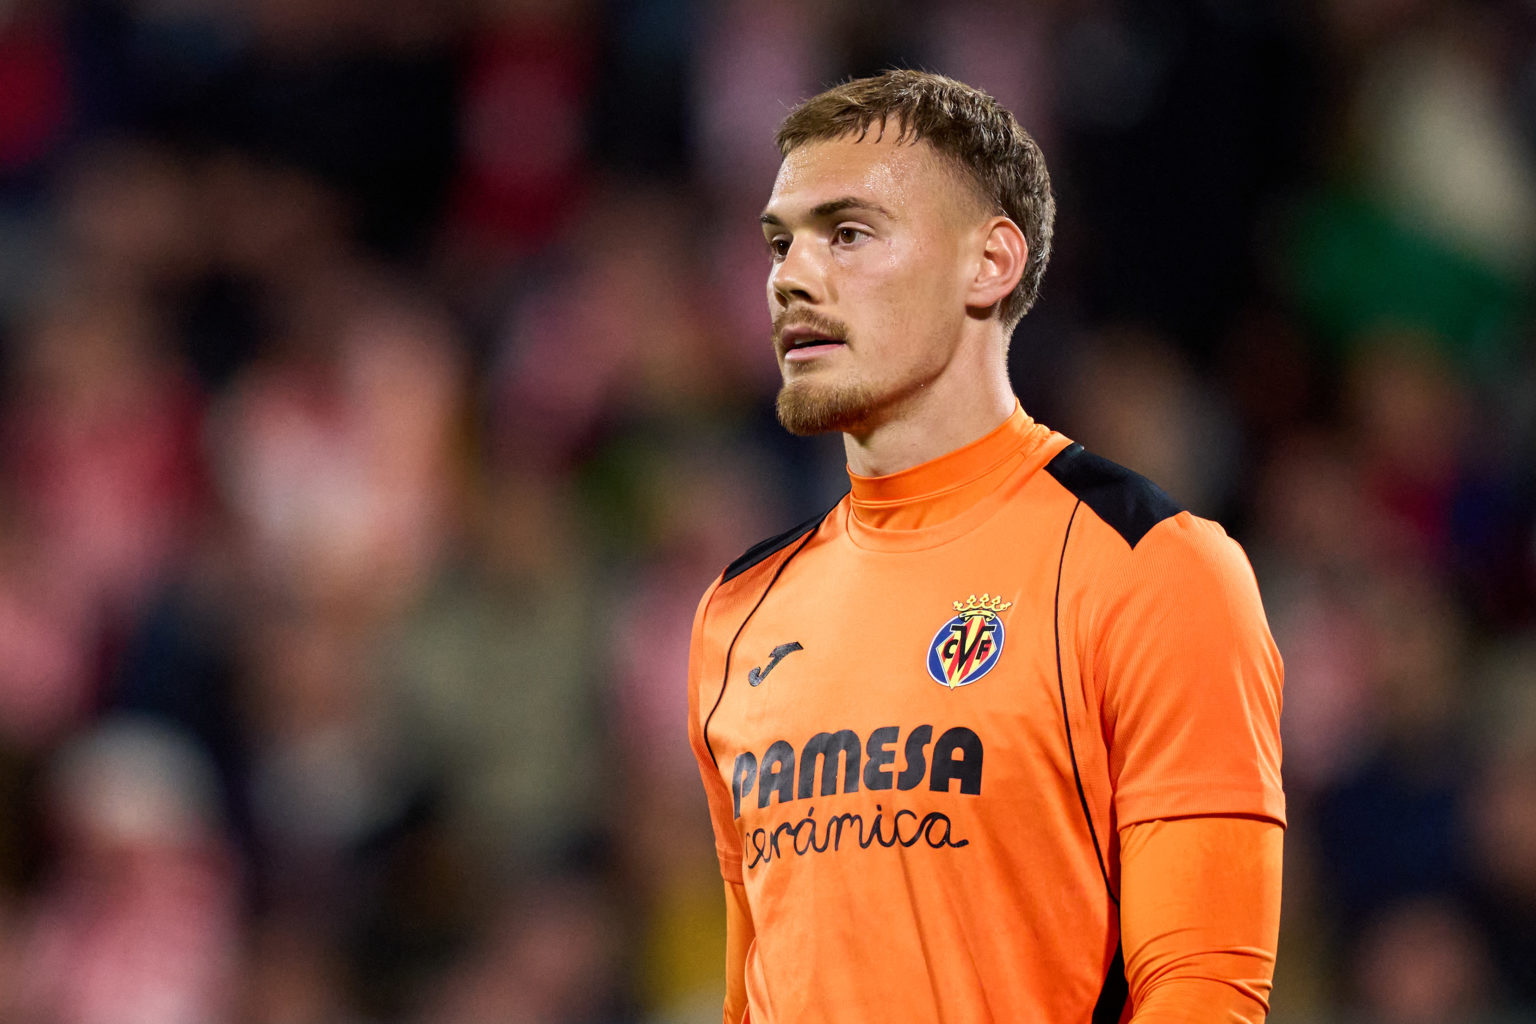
top-left (0, 0), bottom-right (1536, 1024)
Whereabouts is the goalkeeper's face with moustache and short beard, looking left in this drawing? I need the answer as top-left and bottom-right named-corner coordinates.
top-left (762, 129), bottom-right (980, 434)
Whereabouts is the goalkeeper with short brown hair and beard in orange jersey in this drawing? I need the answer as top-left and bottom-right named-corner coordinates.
top-left (688, 71), bottom-right (1284, 1024)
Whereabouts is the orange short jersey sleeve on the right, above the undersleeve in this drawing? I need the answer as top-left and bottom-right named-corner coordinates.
top-left (1095, 513), bottom-right (1286, 827)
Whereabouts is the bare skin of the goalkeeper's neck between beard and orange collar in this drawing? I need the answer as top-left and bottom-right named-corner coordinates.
top-left (843, 363), bottom-right (1017, 476)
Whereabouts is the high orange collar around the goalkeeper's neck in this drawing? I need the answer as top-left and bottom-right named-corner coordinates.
top-left (848, 401), bottom-right (1060, 531)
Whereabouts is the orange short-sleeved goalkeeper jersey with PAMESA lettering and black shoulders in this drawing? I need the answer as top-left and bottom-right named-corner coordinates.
top-left (688, 408), bottom-right (1284, 1024)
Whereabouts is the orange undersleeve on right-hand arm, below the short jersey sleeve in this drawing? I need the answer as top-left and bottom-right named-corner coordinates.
top-left (1120, 818), bottom-right (1281, 1024)
